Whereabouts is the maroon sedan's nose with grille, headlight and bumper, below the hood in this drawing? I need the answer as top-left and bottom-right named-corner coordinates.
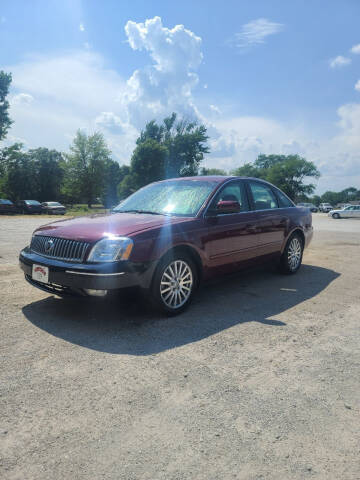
top-left (19, 229), bottom-right (155, 296)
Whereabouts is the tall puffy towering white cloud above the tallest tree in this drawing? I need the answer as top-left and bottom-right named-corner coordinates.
top-left (119, 17), bottom-right (203, 128)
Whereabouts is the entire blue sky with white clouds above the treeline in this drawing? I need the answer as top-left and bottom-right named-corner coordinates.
top-left (0, 0), bottom-right (360, 192)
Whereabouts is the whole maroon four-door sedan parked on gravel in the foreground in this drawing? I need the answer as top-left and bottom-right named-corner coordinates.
top-left (20, 176), bottom-right (313, 314)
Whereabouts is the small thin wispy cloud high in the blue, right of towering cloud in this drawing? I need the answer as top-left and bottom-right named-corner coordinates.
top-left (231, 18), bottom-right (284, 48)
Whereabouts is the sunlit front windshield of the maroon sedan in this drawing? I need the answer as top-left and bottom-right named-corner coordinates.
top-left (113, 180), bottom-right (217, 217)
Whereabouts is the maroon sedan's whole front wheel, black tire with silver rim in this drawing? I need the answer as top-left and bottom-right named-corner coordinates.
top-left (147, 252), bottom-right (198, 316)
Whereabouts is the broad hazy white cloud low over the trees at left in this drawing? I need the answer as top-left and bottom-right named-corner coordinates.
top-left (6, 51), bottom-right (136, 158)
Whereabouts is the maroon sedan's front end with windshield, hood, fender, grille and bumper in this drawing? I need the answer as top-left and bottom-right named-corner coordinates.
top-left (19, 179), bottom-right (216, 302)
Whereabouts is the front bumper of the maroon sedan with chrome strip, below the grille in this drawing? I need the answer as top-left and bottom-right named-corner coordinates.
top-left (19, 247), bottom-right (155, 295)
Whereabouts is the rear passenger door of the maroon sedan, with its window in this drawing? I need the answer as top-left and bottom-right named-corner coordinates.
top-left (247, 180), bottom-right (289, 255)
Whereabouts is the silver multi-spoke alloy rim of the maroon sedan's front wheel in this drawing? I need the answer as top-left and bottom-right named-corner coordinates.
top-left (160, 260), bottom-right (194, 309)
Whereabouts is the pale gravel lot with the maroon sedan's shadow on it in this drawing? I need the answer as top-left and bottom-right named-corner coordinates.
top-left (0, 214), bottom-right (360, 480)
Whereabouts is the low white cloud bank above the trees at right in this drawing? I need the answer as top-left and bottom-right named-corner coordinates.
top-left (205, 107), bottom-right (360, 193)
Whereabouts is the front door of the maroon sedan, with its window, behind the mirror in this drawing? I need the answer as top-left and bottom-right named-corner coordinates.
top-left (205, 180), bottom-right (258, 268)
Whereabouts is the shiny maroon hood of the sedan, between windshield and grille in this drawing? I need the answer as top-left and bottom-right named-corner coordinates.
top-left (34, 213), bottom-right (193, 242)
